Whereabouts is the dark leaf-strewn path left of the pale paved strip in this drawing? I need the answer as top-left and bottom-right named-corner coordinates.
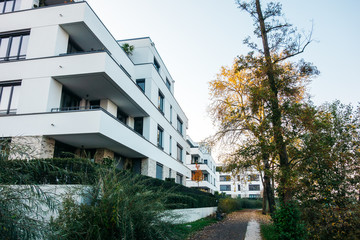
top-left (188, 210), bottom-right (269, 240)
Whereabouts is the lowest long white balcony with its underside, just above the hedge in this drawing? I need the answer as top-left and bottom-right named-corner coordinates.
top-left (0, 108), bottom-right (190, 177)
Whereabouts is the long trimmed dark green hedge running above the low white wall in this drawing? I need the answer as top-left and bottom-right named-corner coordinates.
top-left (0, 158), bottom-right (217, 209)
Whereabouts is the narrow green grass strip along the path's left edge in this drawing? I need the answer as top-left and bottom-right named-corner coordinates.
top-left (174, 217), bottom-right (217, 239)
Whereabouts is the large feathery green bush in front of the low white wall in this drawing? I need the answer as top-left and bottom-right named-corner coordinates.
top-left (51, 169), bottom-right (179, 240)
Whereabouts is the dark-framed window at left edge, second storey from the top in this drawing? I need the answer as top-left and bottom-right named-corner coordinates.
top-left (0, 32), bottom-right (30, 61)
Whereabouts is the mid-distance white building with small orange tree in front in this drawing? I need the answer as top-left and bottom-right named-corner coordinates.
top-left (186, 136), bottom-right (218, 194)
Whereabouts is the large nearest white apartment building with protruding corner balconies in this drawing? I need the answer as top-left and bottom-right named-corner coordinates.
top-left (0, 0), bottom-right (191, 184)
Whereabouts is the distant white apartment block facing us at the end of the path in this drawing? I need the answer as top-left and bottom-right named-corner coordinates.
top-left (216, 166), bottom-right (263, 198)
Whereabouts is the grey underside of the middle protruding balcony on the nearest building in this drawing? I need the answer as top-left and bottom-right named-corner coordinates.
top-left (54, 73), bottom-right (148, 117)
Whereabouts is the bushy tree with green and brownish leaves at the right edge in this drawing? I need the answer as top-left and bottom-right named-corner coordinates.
top-left (296, 101), bottom-right (360, 239)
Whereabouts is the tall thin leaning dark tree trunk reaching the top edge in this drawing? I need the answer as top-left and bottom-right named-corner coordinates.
top-left (256, 0), bottom-right (292, 203)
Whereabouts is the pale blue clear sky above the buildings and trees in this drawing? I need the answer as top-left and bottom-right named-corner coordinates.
top-left (88, 0), bottom-right (360, 141)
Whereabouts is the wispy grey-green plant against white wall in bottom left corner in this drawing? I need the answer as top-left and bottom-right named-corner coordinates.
top-left (0, 141), bottom-right (57, 240)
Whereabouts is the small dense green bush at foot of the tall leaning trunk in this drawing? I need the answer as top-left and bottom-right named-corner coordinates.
top-left (273, 202), bottom-right (306, 240)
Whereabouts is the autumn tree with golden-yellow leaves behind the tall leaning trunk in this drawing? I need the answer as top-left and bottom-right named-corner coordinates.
top-left (210, 53), bottom-right (313, 212)
